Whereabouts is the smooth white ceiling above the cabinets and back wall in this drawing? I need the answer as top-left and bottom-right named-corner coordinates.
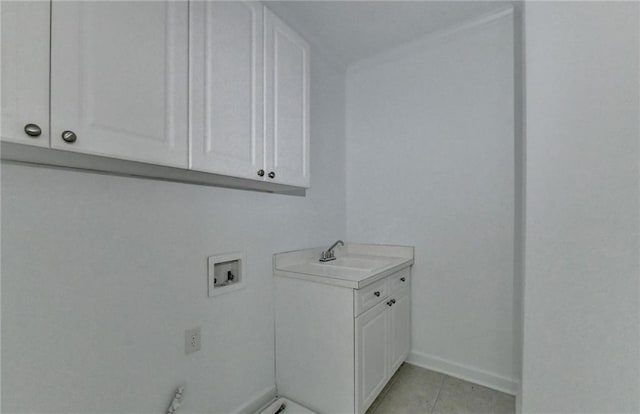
top-left (269, 0), bottom-right (510, 65)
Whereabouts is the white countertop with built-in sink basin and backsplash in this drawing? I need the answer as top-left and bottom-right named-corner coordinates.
top-left (273, 244), bottom-right (413, 289)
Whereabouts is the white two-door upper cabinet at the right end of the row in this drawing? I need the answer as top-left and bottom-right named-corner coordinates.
top-left (189, 1), bottom-right (309, 187)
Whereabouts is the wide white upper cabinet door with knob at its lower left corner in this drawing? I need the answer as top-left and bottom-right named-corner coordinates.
top-left (51, 0), bottom-right (189, 168)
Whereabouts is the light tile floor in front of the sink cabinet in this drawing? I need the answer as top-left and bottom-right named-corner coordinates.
top-left (366, 362), bottom-right (516, 414)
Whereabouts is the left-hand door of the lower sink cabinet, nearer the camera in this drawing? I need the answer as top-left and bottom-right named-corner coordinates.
top-left (355, 301), bottom-right (391, 414)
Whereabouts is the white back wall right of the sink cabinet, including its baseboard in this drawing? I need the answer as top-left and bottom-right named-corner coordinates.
top-left (347, 11), bottom-right (517, 393)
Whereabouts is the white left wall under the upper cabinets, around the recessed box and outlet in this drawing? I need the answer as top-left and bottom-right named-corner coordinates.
top-left (2, 54), bottom-right (345, 414)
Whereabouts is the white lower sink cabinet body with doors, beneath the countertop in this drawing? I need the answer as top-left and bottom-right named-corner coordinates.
top-left (275, 265), bottom-right (411, 414)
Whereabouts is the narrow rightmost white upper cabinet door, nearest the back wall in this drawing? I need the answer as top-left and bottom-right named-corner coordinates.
top-left (264, 8), bottom-right (309, 187)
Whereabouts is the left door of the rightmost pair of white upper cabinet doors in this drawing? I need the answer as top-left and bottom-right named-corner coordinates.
top-left (189, 1), bottom-right (264, 180)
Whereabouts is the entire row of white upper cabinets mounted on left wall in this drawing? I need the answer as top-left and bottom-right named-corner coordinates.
top-left (0, 0), bottom-right (309, 192)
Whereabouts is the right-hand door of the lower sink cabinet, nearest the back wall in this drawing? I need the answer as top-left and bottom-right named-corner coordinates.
top-left (389, 289), bottom-right (411, 375)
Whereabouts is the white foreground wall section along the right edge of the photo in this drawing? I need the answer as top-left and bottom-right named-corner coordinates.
top-left (522, 2), bottom-right (640, 413)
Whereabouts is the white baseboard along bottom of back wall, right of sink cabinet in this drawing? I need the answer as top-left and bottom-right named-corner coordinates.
top-left (407, 351), bottom-right (518, 395)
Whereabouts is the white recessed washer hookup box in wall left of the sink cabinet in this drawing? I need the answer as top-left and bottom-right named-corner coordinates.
top-left (207, 253), bottom-right (245, 297)
